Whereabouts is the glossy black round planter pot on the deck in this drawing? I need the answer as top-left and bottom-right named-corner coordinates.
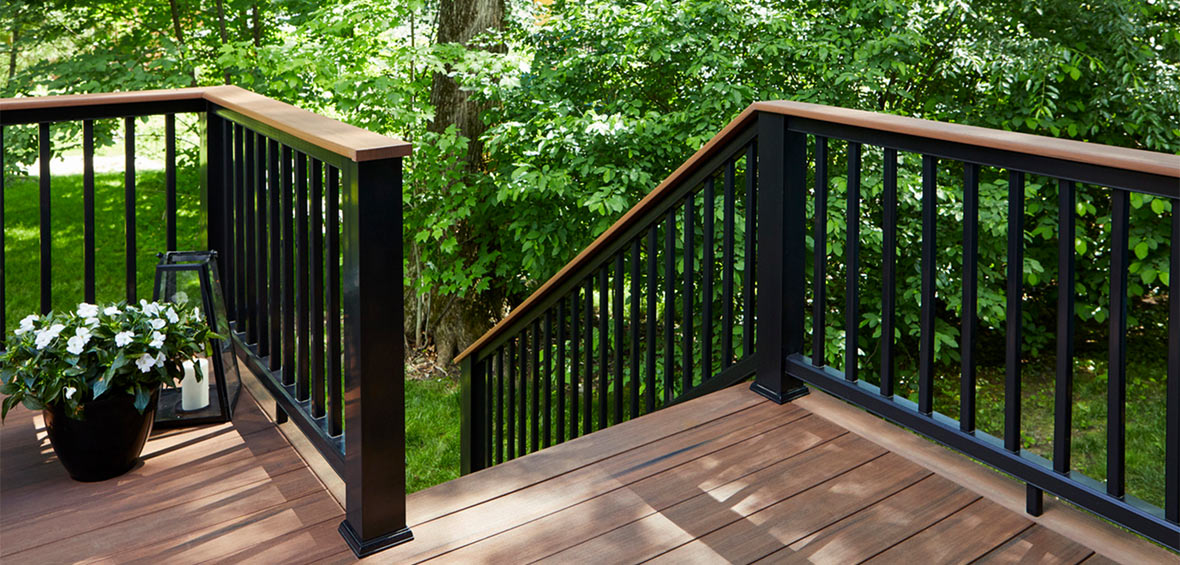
top-left (42, 387), bottom-right (159, 482)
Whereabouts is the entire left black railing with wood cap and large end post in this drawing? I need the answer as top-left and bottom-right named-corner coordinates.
top-left (0, 86), bottom-right (412, 556)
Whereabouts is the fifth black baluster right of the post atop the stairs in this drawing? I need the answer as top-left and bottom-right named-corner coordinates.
top-left (959, 163), bottom-right (979, 433)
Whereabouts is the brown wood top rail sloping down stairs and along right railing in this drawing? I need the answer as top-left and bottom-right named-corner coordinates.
top-left (455, 100), bottom-right (1180, 362)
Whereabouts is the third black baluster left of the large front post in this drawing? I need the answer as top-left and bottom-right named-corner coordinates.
top-left (295, 152), bottom-right (312, 400)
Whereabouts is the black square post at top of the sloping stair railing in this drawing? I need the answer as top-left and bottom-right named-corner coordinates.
top-left (750, 113), bottom-right (807, 405)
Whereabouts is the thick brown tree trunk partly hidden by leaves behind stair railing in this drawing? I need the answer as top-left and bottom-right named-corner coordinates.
top-left (424, 0), bottom-right (505, 364)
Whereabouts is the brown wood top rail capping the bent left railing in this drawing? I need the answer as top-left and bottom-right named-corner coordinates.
top-left (0, 86), bottom-right (411, 162)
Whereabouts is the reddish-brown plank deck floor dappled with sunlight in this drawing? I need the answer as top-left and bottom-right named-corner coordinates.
top-left (0, 387), bottom-right (1180, 565)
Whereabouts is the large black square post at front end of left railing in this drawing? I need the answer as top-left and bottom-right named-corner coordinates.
top-left (340, 158), bottom-right (413, 557)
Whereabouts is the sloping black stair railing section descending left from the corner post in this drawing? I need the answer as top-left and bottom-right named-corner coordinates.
top-left (458, 110), bottom-right (792, 473)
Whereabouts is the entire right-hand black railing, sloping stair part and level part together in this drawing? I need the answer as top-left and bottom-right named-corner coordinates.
top-left (461, 103), bottom-right (1180, 548)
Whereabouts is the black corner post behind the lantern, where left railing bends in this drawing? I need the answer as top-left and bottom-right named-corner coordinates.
top-left (197, 107), bottom-right (229, 294)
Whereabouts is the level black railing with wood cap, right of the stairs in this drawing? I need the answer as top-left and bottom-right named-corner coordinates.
top-left (755, 103), bottom-right (1180, 548)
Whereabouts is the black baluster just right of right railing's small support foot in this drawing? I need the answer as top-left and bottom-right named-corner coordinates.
top-left (1053, 180), bottom-right (1076, 474)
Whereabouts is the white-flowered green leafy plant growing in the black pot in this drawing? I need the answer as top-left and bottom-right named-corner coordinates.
top-left (0, 301), bottom-right (216, 418)
